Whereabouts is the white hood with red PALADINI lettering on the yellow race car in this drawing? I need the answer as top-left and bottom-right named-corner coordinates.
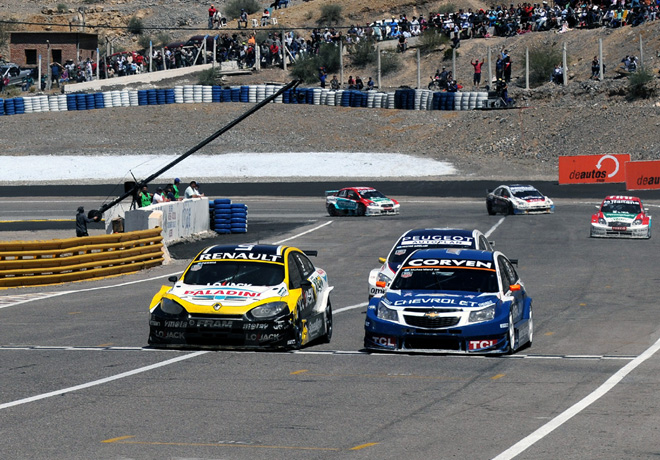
top-left (168, 283), bottom-right (289, 306)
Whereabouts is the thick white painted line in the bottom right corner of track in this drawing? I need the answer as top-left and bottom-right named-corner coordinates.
top-left (493, 339), bottom-right (660, 460)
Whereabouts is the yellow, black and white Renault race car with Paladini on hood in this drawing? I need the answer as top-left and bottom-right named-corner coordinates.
top-left (149, 245), bottom-right (333, 349)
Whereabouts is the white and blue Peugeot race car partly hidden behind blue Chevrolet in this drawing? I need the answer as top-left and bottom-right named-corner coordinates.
top-left (368, 228), bottom-right (493, 299)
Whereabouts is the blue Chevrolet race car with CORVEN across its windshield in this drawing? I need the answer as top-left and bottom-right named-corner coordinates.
top-left (364, 249), bottom-right (534, 354)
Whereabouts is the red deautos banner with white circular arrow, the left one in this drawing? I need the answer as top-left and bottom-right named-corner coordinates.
top-left (559, 153), bottom-right (630, 184)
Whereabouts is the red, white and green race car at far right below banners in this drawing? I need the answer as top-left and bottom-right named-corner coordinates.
top-left (591, 195), bottom-right (651, 238)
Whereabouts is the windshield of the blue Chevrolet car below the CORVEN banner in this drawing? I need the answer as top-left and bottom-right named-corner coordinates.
top-left (391, 267), bottom-right (499, 292)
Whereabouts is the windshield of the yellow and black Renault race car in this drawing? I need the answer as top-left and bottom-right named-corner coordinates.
top-left (183, 260), bottom-right (284, 286)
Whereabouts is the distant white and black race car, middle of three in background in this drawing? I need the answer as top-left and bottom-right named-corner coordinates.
top-left (486, 184), bottom-right (555, 216)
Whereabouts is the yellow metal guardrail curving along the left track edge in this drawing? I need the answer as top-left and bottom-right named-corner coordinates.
top-left (0, 228), bottom-right (164, 288)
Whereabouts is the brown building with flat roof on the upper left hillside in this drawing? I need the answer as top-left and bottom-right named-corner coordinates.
top-left (9, 32), bottom-right (98, 74)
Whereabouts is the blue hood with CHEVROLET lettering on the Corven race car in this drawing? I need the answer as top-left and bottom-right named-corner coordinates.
top-left (385, 291), bottom-right (499, 309)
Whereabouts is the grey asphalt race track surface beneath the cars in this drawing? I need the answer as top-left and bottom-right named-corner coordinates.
top-left (0, 190), bottom-right (660, 460)
